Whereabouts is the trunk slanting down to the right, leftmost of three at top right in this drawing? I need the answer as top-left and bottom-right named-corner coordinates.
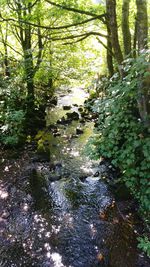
top-left (106, 0), bottom-right (123, 70)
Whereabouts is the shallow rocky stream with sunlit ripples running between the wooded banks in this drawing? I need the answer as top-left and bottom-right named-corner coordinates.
top-left (0, 88), bottom-right (145, 267)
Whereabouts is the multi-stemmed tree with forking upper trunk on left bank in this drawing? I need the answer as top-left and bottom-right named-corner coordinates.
top-left (9, 0), bottom-right (43, 113)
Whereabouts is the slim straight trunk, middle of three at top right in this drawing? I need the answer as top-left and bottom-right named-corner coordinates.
top-left (122, 0), bottom-right (131, 56)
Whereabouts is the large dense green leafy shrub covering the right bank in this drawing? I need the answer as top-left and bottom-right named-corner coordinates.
top-left (87, 49), bottom-right (150, 218)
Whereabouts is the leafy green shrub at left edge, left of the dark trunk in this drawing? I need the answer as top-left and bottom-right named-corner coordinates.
top-left (0, 78), bottom-right (25, 146)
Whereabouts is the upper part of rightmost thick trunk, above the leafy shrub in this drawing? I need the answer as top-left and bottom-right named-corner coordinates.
top-left (136, 0), bottom-right (148, 52)
